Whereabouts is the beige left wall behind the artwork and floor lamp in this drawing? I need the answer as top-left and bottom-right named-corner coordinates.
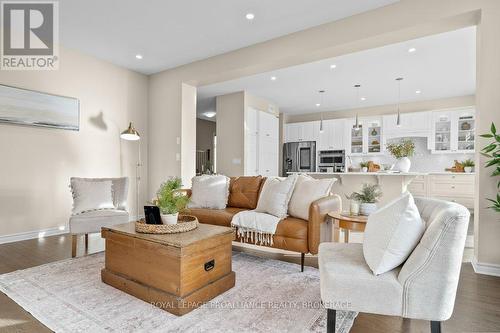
top-left (0, 48), bottom-right (148, 240)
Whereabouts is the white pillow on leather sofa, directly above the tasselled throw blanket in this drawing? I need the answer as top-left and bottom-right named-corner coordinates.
top-left (255, 175), bottom-right (297, 219)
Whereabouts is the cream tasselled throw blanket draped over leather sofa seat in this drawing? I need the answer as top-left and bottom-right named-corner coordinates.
top-left (231, 210), bottom-right (281, 246)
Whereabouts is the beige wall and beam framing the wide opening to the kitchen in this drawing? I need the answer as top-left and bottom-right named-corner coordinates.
top-left (149, 0), bottom-right (500, 271)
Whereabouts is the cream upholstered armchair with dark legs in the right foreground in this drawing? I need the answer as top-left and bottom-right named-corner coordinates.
top-left (318, 198), bottom-right (470, 333)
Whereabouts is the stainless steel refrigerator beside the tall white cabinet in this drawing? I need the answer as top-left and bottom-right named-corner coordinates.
top-left (283, 141), bottom-right (316, 176)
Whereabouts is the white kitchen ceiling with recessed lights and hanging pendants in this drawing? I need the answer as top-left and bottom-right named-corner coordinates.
top-left (198, 27), bottom-right (476, 118)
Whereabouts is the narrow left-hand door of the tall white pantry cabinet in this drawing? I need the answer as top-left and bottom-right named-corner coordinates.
top-left (244, 108), bottom-right (260, 176)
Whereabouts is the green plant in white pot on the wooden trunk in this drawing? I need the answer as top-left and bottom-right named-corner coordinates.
top-left (153, 177), bottom-right (189, 224)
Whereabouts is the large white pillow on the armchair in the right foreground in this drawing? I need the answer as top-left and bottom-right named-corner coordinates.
top-left (363, 192), bottom-right (425, 275)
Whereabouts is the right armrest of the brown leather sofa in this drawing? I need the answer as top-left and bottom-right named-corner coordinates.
top-left (307, 194), bottom-right (342, 254)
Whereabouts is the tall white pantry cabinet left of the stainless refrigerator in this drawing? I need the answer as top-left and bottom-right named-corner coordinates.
top-left (244, 107), bottom-right (279, 177)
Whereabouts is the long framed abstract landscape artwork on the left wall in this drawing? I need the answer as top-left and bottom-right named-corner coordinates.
top-left (0, 85), bottom-right (80, 131)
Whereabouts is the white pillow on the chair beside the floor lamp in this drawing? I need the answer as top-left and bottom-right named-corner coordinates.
top-left (71, 178), bottom-right (115, 215)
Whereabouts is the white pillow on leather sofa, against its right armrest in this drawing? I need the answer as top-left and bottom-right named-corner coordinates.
top-left (288, 174), bottom-right (337, 220)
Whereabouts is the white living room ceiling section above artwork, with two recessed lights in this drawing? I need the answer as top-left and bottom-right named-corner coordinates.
top-left (59, 0), bottom-right (398, 74)
